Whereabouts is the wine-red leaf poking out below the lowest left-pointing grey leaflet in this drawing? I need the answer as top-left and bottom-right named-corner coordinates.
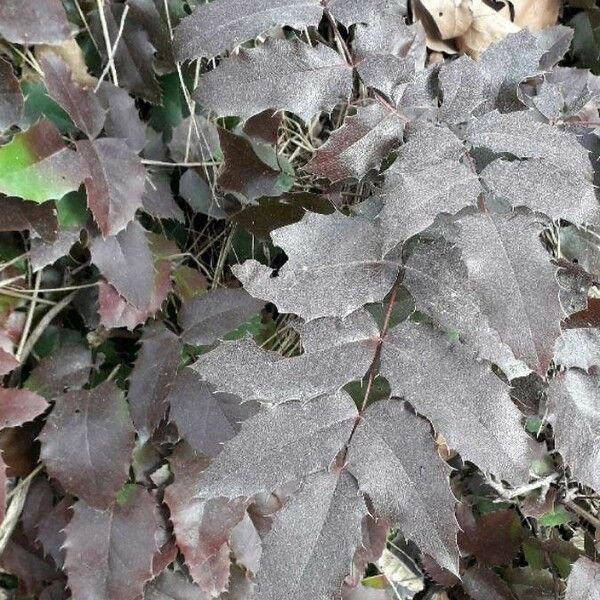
top-left (165, 443), bottom-right (246, 597)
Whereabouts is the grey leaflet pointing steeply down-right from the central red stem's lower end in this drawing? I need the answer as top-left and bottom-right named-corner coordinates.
top-left (348, 400), bottom-right (459, 573)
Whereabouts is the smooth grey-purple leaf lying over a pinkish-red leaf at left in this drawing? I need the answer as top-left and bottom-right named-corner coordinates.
top-left (90, 221), bottom-right (155, 309)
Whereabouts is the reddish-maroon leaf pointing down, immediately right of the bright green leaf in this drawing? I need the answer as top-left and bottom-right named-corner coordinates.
top-left (76, 138), bottom-right (146, 236)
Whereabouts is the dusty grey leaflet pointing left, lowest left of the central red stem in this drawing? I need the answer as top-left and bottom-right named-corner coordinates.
top-left (197, 392), bottom-right (358, 498)
